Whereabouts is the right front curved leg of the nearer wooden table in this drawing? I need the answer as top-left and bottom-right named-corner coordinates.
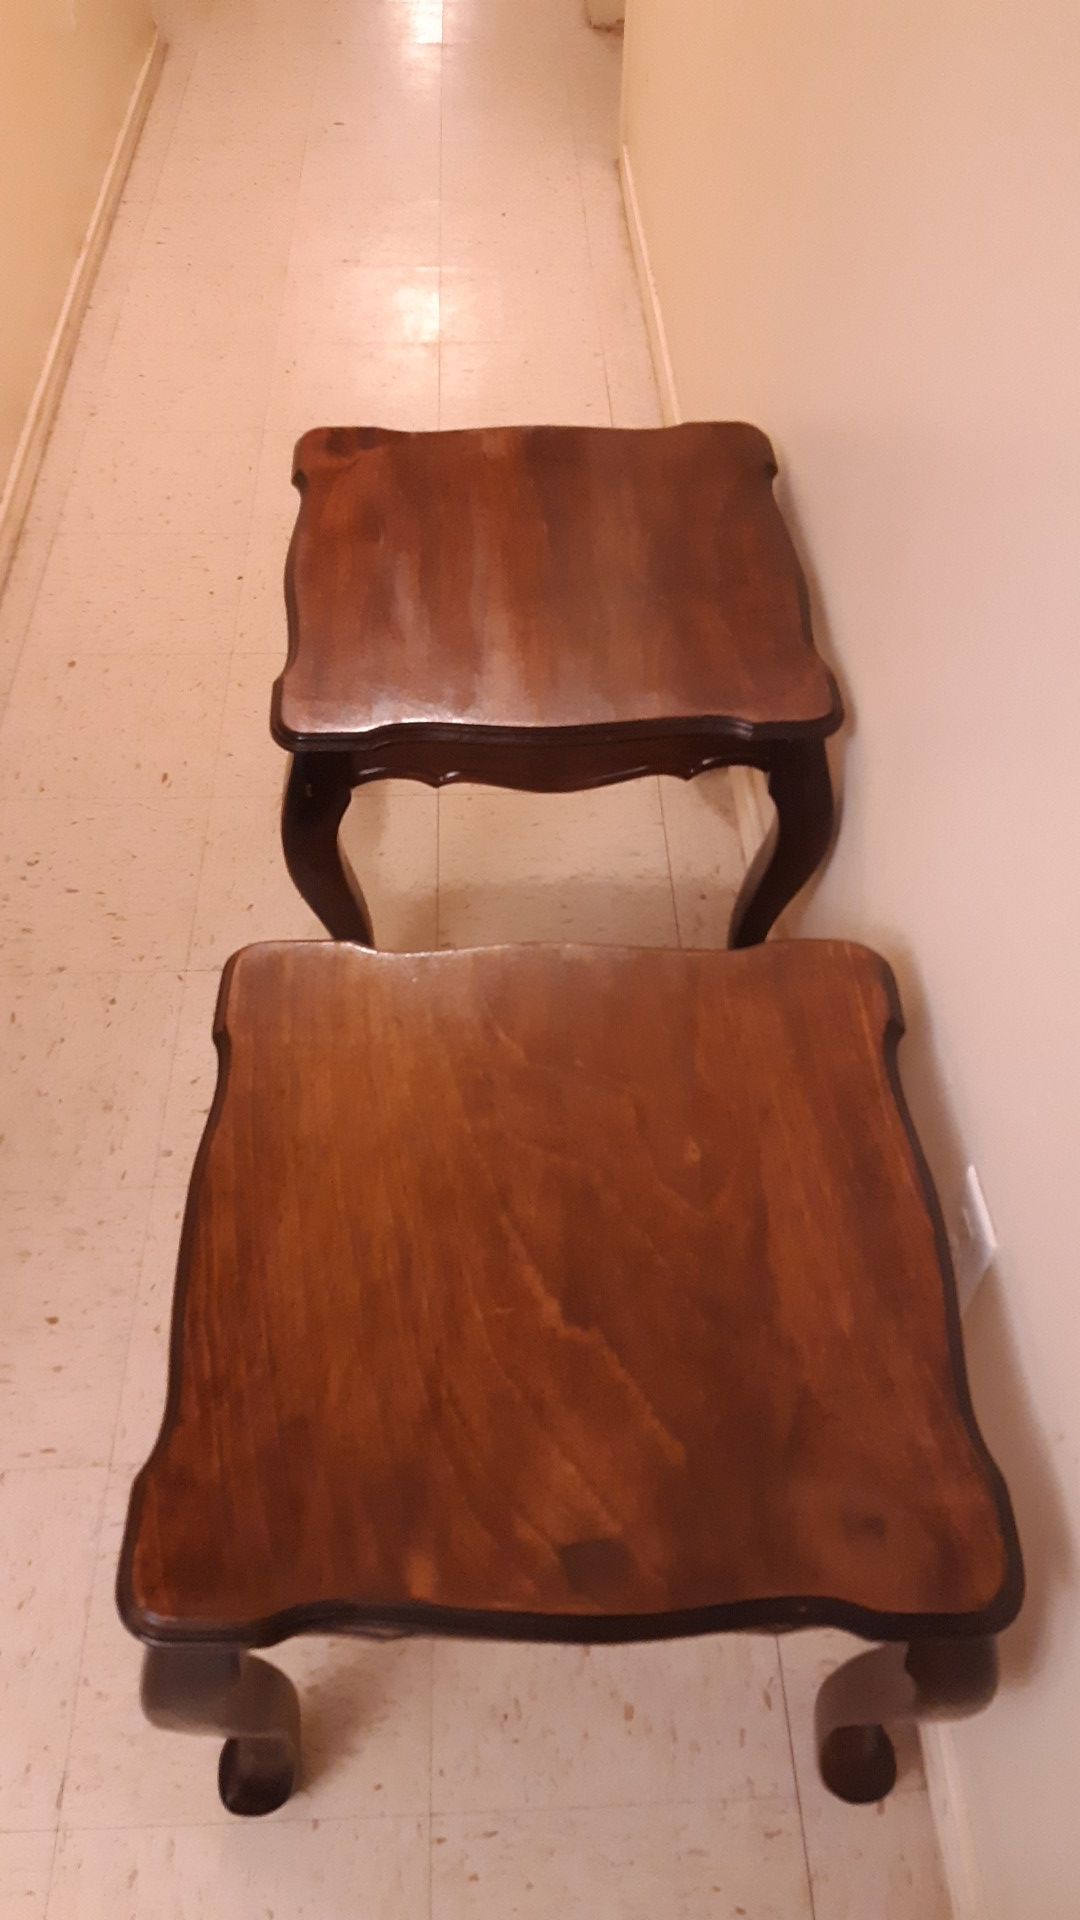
top-left (815, 1640), bottom-right (997, 1805)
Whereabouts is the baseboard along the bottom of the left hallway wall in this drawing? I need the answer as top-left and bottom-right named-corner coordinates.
top-left (0, 33), bottom-right (165, 586)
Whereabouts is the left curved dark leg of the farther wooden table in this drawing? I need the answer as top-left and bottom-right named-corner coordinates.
top-left (281, 753), bottom-right (375, 947)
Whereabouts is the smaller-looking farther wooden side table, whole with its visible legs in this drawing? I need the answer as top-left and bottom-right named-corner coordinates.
top-left (271, 422), bottom-right (842, 945)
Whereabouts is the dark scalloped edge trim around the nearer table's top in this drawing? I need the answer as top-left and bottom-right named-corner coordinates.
top-left (115, 941), bottom-right (1024, 1647)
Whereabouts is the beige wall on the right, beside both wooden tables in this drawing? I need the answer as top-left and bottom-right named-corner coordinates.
top-left (625, 0), bottom-right (1080, 1920)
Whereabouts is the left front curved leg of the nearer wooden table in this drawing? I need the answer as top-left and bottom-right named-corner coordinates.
top-left (142, 1645), bottom-right (300, 1814)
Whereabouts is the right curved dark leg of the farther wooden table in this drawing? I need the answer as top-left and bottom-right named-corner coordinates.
top-left (728, 739), bottom-right (832, 947)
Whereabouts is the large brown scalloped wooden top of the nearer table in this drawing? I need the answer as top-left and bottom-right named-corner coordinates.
top-left (119, 941), bottom-right (1020, 1644)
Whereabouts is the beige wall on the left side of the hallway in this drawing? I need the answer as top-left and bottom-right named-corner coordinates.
top-left (0, 0), bottom-right (152, 493)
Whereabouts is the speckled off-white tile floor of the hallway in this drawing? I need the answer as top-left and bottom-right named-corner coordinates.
top-left (0, 0), bottom-right (945, 1920)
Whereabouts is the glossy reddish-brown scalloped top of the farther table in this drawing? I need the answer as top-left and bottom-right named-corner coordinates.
top-left (273, 422), bottom-right (842, 749)
